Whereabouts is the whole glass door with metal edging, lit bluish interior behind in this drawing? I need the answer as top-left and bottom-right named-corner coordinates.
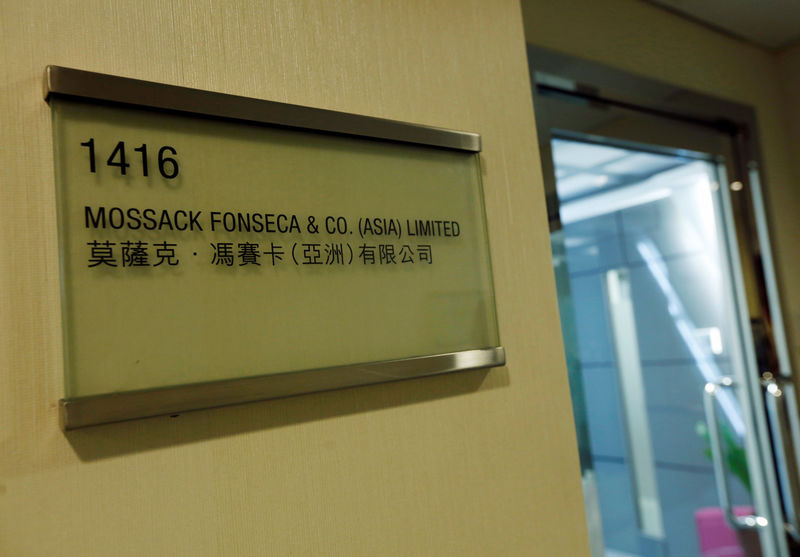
top-left (535, 56), bottom-right (789, 557)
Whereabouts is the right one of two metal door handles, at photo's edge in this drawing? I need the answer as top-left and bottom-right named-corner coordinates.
top-left (762, 372), bottom-right (800, 541)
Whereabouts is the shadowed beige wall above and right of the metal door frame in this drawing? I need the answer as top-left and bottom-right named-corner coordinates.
top-left (522, 0), bottom-right (800, 370)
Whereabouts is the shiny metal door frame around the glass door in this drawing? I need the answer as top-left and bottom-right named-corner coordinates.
top-left (528, 45), bottom-right (800, 557)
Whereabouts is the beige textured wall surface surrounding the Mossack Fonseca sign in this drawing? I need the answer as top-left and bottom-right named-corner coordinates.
top-left (0, 0), bottom-right (586, 557)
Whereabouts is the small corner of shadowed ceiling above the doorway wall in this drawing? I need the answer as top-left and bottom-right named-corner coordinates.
top-left (647, 0), bottom-right (800, 48)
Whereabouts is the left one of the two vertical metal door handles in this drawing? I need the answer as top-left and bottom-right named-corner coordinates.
top-left (703, 377), bottom-right (769, 530)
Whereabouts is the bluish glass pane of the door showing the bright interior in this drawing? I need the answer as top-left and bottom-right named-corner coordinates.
top-left (552, 139), bottom-right (751, 557)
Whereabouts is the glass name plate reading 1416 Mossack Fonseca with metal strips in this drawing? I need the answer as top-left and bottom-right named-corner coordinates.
top-left (45, 66), bottom-right (505, 429)
